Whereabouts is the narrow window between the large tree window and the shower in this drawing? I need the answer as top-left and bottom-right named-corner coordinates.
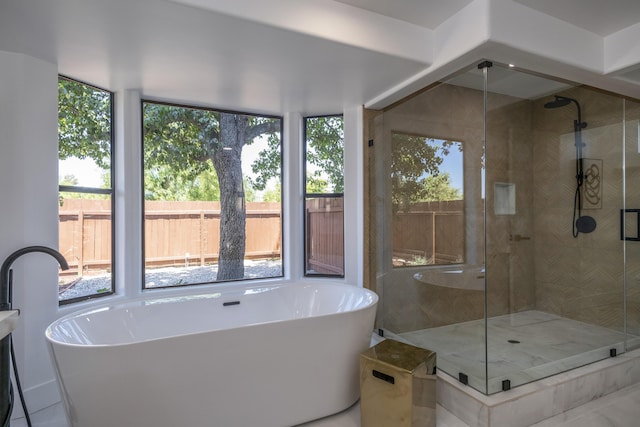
top-left (304, 116), bottom-right (344, 277)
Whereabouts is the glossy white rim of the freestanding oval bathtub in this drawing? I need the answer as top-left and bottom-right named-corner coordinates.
top-left (45, 282), bottom-right (379, 349)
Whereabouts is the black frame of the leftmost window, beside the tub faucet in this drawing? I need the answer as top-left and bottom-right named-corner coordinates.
top-left (58, 74), bottom-right (117, 306)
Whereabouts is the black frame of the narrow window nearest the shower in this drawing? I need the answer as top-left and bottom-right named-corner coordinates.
top-left (302, 114), bottom-right (346, 279)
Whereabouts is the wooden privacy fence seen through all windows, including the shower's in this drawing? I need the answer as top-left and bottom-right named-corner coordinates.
top-left (59, 197), bottom-right (464, 275)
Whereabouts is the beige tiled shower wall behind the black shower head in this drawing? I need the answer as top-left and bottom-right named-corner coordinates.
top-left (532, 88), bottom-right (640, 331)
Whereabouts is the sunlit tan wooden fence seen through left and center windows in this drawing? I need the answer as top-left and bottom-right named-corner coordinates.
top-left (59, 199), bottom-right (282, 275)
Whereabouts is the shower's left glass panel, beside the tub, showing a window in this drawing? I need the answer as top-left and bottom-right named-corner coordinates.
top-left (369, 62), bottom-right (486, 392)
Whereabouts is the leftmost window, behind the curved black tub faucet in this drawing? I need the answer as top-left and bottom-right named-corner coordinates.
top-left (58, 77), bottom-right (114, 304)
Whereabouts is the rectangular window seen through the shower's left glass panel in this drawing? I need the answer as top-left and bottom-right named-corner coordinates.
top-left (391, 132), bottom-right (465, 267)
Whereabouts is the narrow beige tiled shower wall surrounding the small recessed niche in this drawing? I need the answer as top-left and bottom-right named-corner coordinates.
top-left (486, 94), bottom-right (535, 317)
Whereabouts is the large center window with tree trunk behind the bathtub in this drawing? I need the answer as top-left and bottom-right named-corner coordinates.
top-left (142, 101), bottom-right (283, 289)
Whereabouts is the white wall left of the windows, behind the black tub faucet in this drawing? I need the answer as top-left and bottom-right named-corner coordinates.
top-left (0, 52), bottom-right (58, 414)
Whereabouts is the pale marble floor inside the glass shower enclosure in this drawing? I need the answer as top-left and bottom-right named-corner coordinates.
top-left (397, 311), bottom-right (639, 394)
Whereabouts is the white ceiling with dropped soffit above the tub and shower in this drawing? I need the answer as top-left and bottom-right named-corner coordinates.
top-left (0, 0), bottom-right (640, 115)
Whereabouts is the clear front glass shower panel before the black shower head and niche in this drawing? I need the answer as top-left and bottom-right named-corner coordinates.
top-left (485, 64), bottom-right (625, 394)
